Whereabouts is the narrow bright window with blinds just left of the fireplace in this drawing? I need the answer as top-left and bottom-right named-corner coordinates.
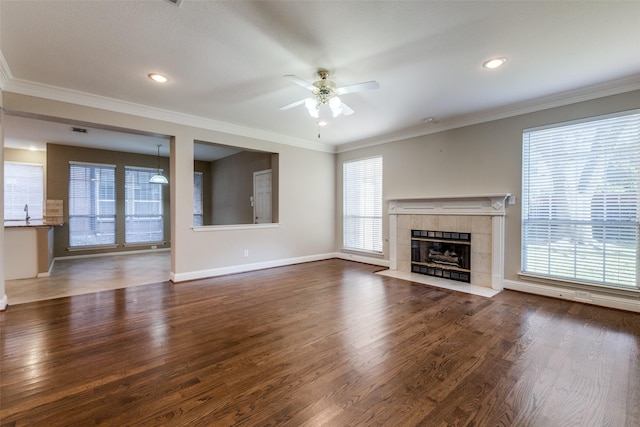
top-left (342, 157), bottom-right (382, 253)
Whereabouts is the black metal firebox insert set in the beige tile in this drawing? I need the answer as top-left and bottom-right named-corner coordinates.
top-left (411, 230), bottom-right (471, 283)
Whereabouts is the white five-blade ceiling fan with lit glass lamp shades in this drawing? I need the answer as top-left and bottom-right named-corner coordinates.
top-left (280, 68), bottom-right (380, 119)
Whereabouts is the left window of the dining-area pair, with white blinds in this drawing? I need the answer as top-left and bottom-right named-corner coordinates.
top-left (69, 163), bottom-right (116, 248)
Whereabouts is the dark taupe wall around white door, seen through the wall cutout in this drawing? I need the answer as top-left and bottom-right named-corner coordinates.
top-left (211, 151), bottom-right (271, 225)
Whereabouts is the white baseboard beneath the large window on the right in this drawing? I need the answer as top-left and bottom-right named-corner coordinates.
top-left (504, 280), bottom-right (640, 313)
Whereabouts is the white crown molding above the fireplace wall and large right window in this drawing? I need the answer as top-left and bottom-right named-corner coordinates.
top-left (336, 74), bottom-right (640, 153)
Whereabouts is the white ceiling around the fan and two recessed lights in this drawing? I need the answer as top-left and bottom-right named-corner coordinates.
top-left (0, 0), bottom-right (640, 154)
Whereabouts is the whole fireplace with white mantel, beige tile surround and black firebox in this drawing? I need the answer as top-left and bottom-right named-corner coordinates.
top-left (387, 193), bottom-right (512, 290)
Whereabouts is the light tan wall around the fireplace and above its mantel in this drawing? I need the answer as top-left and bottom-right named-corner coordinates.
top-left (335, 91), bottom-right (640, 280)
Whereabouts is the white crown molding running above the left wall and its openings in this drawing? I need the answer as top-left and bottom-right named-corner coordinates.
top-left (0, 77), bottom-right (335, 153)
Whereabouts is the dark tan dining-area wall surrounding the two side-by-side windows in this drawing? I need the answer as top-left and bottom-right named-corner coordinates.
top-left (47, 144), bottom-right (171, 258)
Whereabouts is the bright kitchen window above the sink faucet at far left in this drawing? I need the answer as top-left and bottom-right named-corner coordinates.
top-left (4, 162), bottom-right (44, 221)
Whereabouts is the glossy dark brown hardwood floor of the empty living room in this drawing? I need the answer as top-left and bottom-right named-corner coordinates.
top-left (0, 260), bottom-right (640, 427)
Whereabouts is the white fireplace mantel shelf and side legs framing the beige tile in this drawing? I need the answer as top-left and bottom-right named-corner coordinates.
top-left (387, 193), bottom-right (511, 290)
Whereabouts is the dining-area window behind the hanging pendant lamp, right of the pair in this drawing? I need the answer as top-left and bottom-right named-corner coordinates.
top-left (124, 166), bottom-right (164, 244)
